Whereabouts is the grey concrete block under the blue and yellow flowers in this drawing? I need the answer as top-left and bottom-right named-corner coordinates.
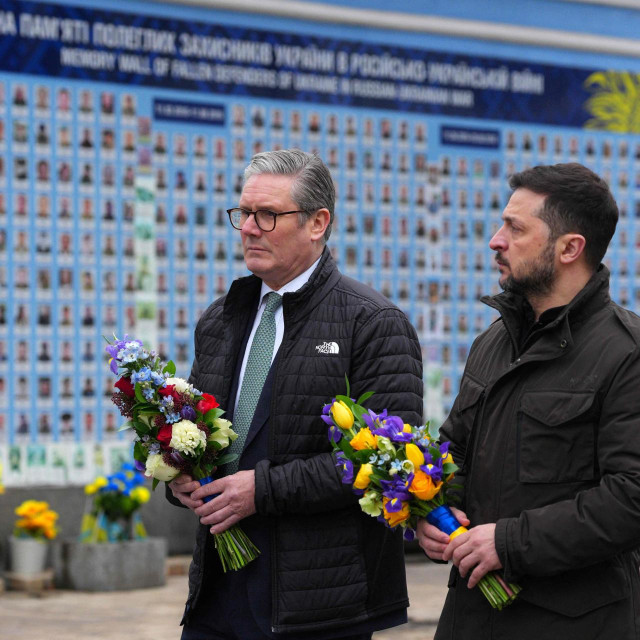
top-left (53, 538), bottom-right (167, 591)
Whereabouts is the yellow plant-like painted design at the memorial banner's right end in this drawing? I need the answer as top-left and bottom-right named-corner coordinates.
top-left (584, 71), bottom-right (640, 133)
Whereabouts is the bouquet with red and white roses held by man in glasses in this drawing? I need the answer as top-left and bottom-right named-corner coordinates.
top-left (106, 336), bottom-right (260, 572)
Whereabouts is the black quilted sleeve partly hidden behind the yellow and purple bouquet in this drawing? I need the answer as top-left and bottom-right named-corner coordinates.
top-left (256, 308), bottom-right (422, 516)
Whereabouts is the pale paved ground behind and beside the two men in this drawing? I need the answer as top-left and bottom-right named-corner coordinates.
top-left (0, 555), bottom-right (449, 640)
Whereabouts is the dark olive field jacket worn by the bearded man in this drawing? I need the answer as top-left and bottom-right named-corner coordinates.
top-left (436, 267), bottom-right (640, 640)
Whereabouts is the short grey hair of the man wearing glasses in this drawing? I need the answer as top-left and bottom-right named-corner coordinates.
top-left (244, 149), bottom-right (336, 244)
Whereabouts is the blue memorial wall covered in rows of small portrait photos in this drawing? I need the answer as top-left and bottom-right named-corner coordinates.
top-left (0, 2), bottom-right (640, 485)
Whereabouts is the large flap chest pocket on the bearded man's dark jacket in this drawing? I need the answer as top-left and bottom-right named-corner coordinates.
top-left (518, 391), bottom-right (597, 483)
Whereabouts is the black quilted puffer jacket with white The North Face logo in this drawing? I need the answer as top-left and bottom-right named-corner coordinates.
top-left (180, 248), bottom-right (422, 632)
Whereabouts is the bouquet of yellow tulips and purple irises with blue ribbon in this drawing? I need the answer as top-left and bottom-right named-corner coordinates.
top-left (321, 381), bottom-right (520, 609)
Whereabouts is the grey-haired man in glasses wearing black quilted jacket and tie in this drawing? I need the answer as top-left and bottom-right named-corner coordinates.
top-left (170, 149), bottom-right (422, 640)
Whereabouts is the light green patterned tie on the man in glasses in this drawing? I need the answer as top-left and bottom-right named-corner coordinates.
top-left (227, 291), bottom-right (282, 473)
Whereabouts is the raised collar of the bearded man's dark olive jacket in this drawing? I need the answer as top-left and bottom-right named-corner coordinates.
top-left (481, 264), bottom-right (610, 352)
